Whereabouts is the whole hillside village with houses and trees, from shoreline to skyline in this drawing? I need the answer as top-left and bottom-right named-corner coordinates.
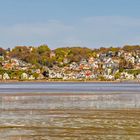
top-left (0, 45), bottom-right (140, 81)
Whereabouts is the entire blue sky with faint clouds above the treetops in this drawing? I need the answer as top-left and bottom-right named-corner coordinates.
top-left (0, 0), bottom-right (140, 49)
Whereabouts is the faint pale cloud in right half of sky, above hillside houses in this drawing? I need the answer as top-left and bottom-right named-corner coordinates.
top-left (76, 16), bottom-right (140, 46)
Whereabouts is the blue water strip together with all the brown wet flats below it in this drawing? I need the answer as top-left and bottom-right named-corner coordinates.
top-left (0, 82), bottom-right (140, 140)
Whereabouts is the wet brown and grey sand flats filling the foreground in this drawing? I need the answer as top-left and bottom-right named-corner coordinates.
top-left (0, 94), bottom-right (140, 140)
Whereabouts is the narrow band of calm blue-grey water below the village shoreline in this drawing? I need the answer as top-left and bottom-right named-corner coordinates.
top-left (0, 82), bottom-right (140, 93)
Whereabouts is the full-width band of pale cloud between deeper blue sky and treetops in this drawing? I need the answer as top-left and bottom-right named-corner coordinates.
top-left (0, 16), bottom-right (140, 48)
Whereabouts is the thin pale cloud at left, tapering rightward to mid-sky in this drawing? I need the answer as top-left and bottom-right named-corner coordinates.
top-left (0, 21), bottom-right (75, 46)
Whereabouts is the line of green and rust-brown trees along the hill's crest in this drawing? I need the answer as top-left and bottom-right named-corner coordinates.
top-left (0, 45), bottom-right (140, 67)
